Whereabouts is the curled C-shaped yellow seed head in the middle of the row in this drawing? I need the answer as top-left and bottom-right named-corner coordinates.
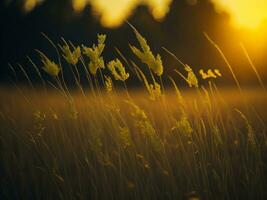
top-left (108, 59), bottom-right (129, 81)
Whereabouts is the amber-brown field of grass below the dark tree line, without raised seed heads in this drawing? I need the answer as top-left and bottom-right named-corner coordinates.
top-left (0, 88), bottom-right (266, 199)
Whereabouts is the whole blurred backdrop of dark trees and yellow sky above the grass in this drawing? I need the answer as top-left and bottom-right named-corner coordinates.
top-left (0, 0), bottom-right (267, 85)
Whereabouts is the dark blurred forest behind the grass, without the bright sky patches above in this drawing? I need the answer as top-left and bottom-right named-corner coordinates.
top-left (0, 0), bottom-right (267, 86)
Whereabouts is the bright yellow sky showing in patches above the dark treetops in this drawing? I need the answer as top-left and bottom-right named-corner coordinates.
top-left (24, 0), bottom-right (267, 29)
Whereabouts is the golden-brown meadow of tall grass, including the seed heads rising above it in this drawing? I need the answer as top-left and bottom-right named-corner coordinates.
top-left (0, 27), bottom-right (267, 200)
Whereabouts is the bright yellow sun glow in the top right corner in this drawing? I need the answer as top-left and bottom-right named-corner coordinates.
top-left (211, 0), bottom-right (267, 29)
